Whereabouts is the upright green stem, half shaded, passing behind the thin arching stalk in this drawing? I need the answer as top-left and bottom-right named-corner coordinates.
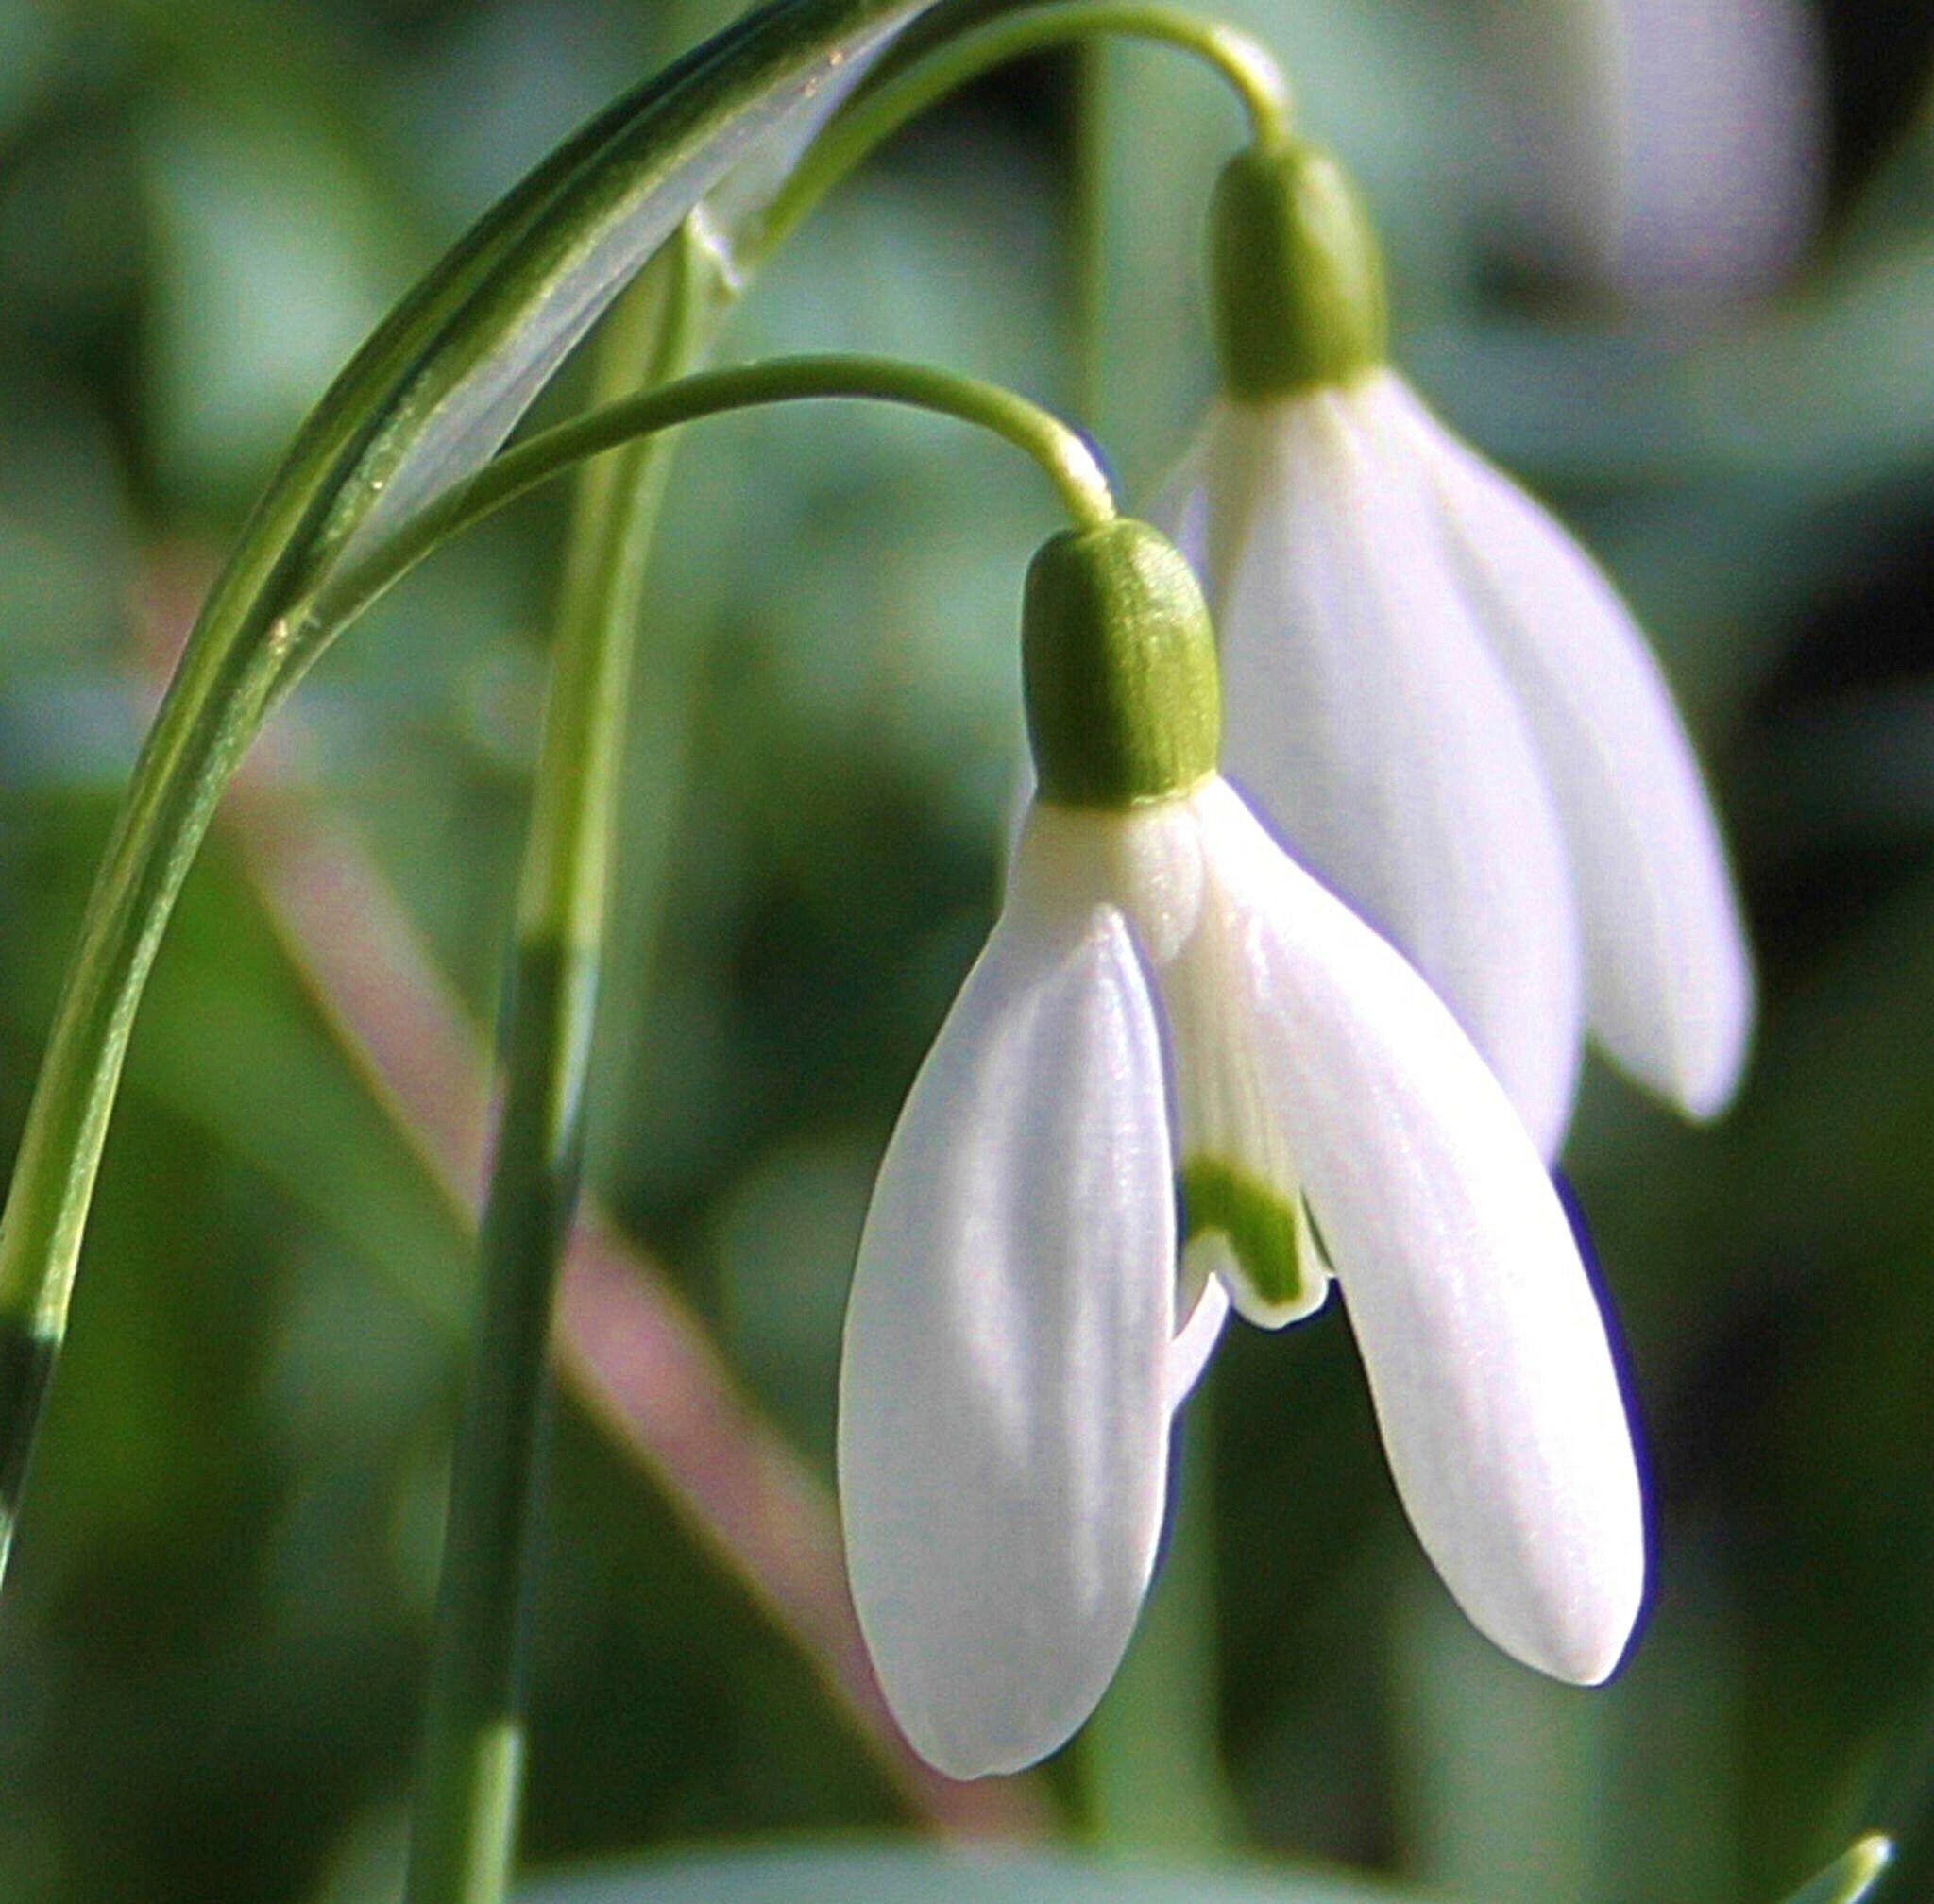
top-left (406, 229), bottom-right (708, 1904)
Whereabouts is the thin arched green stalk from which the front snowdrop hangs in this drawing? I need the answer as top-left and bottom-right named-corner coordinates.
top-left (279, 356), bottom-right (1114, 650)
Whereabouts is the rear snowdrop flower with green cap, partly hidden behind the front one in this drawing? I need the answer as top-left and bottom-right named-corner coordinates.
top-left (1166, 147), bottom-right (1752, 1155)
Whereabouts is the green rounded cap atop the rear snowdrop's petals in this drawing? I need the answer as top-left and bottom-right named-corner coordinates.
top-left (1209, 144), bottom-right (1386, 400)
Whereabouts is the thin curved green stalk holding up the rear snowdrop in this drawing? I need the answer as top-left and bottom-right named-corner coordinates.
top-left (761, 0), bottom-right (1292, 257)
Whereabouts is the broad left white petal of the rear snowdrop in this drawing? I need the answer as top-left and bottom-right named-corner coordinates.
top-left (1205, 380), bottom-right (1584, 1155)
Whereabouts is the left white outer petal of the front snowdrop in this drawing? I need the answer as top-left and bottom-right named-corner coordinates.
top-left (840, 842), bottom-right (1176, 1778)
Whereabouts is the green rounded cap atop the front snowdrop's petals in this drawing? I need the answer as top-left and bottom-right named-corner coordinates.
top-left (1021, 517), bottom-right (1222, 808)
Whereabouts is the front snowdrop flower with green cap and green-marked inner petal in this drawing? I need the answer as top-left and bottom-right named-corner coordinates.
top-left (840, 522), bottom-right (1644, 1776)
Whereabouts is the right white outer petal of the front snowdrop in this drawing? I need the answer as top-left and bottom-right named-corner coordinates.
top-left (1197, 788), bottom-right (1644, 1683)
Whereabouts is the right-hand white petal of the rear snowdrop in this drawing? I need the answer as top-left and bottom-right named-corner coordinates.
top-left (1384, 380), bottom-right (1752, 1116)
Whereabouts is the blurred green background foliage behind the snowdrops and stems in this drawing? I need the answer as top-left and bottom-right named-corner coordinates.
top-left (0, 0), bottom-right (1934, 1904)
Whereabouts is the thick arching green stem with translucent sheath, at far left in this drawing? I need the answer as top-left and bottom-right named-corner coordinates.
top-left (0, 0), bottom-right (925, 1563)
